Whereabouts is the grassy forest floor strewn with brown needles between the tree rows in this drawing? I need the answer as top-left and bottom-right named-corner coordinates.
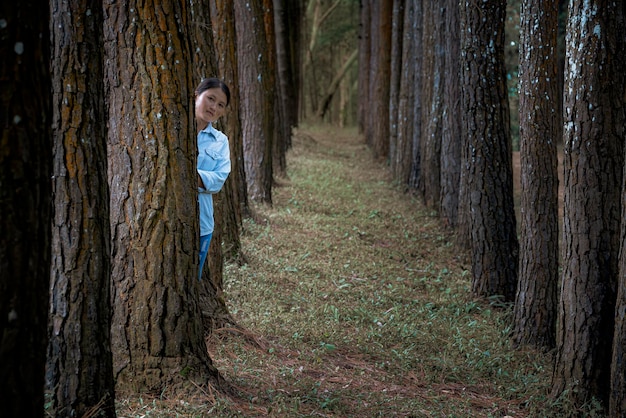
top-left (118, 127), bottom-right (567, 417)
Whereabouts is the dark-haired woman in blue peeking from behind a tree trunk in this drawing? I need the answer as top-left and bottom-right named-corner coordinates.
top-left (195, 78), bottom-right (230, 280)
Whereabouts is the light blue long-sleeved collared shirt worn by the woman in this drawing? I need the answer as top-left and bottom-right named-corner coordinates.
top-left (198, 123), bottom-right (230, 236)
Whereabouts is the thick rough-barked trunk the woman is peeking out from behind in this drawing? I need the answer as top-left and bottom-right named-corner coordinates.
top-left (104, 1), bottom-right (221, 393)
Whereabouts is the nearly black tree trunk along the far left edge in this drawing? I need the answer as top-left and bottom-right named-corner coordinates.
top-left (0, 0), bottom-right (52, 417)
